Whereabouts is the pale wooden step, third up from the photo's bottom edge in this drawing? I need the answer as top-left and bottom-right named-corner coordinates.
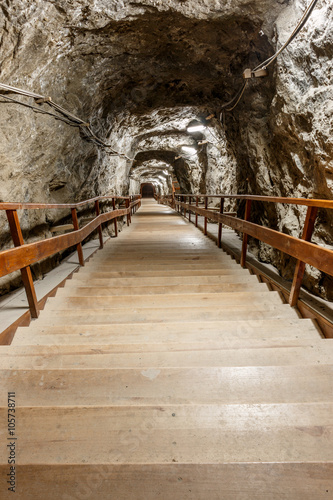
top-left (0, 364), bottom-right (333, 408)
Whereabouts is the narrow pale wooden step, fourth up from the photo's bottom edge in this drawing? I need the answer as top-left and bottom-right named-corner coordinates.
top-left (0, 340), bottom-right (333, 370)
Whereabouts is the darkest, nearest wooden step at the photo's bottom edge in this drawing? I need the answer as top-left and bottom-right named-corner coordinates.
top-left (0, 460), bottom-right (333, 500)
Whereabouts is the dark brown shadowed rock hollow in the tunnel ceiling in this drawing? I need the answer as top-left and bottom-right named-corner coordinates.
top-left (84, 12), bottom-right (270, 113)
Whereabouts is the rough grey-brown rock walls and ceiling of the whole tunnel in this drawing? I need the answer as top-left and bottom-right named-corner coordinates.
top-left (0, 0), bottom-right (333, 300)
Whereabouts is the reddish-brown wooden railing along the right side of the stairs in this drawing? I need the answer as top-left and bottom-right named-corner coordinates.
top-left (159, 194), bottom-right (333, 306)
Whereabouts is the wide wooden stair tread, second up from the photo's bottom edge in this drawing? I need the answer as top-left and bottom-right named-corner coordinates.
top-left (0, 403), bottom-right (333, 465)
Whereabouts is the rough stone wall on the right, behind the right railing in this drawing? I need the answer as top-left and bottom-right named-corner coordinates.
top-left (220, 0), bottom-right (333, 300)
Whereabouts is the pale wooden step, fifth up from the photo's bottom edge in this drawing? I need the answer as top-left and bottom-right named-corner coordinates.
top-left (12, 316), bottom-right (320, 349)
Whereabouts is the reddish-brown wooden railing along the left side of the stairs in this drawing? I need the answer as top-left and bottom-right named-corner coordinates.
top-left (0, 195), bottom-right (141, 318)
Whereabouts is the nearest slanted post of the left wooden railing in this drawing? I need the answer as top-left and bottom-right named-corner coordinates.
top-left (6, 210), bottom-right (39, 318)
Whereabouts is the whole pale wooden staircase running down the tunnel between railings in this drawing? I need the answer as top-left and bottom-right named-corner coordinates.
top-left (0, 200), bottom-right (333, 500)
